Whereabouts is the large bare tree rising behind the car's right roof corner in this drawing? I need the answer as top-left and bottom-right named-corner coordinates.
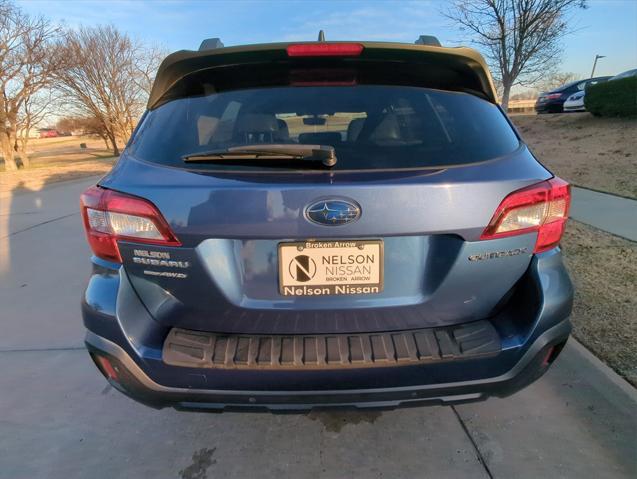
top-left (444, 0), bottom-right (586, 110)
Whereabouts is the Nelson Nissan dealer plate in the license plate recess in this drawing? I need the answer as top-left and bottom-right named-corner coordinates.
top-left (279, 240), bottom-right (383, 296)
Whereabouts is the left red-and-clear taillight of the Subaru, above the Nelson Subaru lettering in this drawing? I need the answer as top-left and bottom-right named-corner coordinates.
top-left (80, 186), bottom-right (181, 263)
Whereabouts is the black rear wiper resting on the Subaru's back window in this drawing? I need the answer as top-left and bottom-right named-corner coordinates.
top-left (182, 144), bottom-right (336, 168)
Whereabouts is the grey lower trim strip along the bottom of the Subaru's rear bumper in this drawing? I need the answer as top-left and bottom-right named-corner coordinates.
top-left (86, 320), bottom-right (571, 410)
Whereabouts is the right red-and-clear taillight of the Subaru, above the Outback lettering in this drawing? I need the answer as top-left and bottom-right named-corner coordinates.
top-left (480, 178), bottom-right (571, 253)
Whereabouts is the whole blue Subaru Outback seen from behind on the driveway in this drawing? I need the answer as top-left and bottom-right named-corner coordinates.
top-left (81, 39), bottom-right (573, 410)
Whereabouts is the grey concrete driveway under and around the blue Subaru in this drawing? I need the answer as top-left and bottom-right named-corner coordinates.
top-left (0, 179), bottom-right (637, 479)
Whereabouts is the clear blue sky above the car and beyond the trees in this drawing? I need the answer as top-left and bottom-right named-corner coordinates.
top-left (17, 0), bottom-right (637, 87)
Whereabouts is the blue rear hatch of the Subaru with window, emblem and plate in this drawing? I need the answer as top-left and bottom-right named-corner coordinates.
top-left (92, 44), bottom-right (551, 334)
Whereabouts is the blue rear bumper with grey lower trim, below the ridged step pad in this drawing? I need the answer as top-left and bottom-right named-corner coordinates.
top-left (83, 249), bottom-right (573, 410)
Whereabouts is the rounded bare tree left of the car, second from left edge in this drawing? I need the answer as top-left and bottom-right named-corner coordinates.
top-left (56, 26), bottom-right (158, 155)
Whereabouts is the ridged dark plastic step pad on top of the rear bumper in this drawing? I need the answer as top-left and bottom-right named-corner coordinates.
top-left (163, 321), bottom-right (501, 370)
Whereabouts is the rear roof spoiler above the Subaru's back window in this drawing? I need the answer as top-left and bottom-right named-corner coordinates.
top-left (147, 42), bottom-right (497, 110)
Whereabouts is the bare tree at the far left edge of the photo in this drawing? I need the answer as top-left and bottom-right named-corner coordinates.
top-left (0, 0), bottom-right (59, 170)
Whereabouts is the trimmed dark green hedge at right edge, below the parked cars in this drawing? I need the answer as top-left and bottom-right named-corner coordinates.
top-left (584, 77), bottom-right (637, 116)
